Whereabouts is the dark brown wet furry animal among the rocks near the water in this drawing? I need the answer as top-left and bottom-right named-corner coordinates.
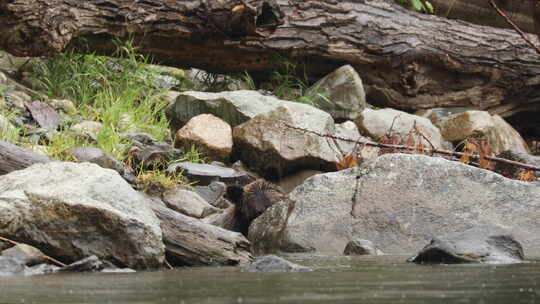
top-left (218, 179), bottom-right (285, 237)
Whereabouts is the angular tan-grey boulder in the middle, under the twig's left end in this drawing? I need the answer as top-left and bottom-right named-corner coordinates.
top-left (233, 103), bottom-right (340, 178)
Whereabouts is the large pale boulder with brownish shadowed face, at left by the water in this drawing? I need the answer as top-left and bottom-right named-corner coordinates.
top-left (0, 162), bottom-right (164, 268)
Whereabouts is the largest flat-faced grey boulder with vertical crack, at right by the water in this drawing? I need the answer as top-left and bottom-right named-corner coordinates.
top-left (272, 154), bottom-right (540, 254)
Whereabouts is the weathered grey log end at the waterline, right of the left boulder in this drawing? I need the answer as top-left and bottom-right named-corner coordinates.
top-left (152, 204), bottom-right (253, 266)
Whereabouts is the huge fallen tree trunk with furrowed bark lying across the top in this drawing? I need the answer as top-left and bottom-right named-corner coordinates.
top-left (0, 0), bottom-right (540, 116)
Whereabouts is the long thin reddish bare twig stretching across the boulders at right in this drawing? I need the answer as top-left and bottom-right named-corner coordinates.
top-left (281, 122), bottom-right (540, 172)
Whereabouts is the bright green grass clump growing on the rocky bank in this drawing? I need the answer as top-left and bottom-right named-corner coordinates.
top-left (33, 41), bottom-right (168, 160)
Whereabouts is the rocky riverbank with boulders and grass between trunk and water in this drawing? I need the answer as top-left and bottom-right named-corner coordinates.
top-left (0, 43), bottom-right (540, 273)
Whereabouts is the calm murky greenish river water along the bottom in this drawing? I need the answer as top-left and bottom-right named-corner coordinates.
top-left (0, 256), bottom-right (540, 304)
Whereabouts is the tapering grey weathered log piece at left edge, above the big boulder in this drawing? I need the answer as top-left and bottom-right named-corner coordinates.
top-left (0, 141), bottom-right (53, 175)
